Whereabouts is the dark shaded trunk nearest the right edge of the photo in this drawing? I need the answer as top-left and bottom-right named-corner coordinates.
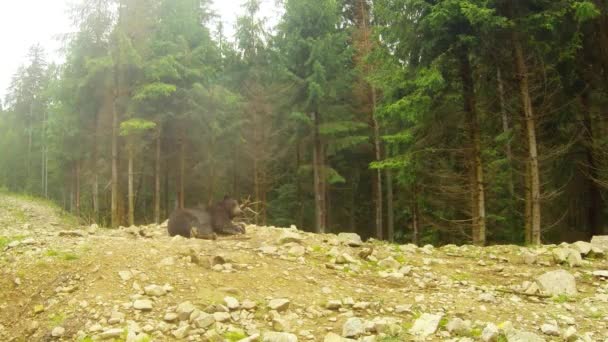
top-left (581, 90), bottom-right (604, 236)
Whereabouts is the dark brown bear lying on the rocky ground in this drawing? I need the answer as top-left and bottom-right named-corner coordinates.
top-left (167, 196), bottom-right (245, 240)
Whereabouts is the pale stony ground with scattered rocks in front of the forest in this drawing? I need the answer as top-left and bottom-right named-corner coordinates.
top-left (0, 195), bottom-right (608, 342)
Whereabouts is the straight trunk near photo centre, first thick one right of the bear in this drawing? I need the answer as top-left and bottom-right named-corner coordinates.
top-left (311, 112), bottom-right (326, 234)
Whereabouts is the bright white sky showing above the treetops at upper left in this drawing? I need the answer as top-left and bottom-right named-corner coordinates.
top-left (0, 0), bottom-right (279, 103)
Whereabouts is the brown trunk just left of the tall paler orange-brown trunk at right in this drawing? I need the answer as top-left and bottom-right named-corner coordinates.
top-left (460, 48), bottom-right (486, 246)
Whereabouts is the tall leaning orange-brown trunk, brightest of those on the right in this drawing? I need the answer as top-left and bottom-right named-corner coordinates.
top-left (511, 32), bottom-right (541, 245)
